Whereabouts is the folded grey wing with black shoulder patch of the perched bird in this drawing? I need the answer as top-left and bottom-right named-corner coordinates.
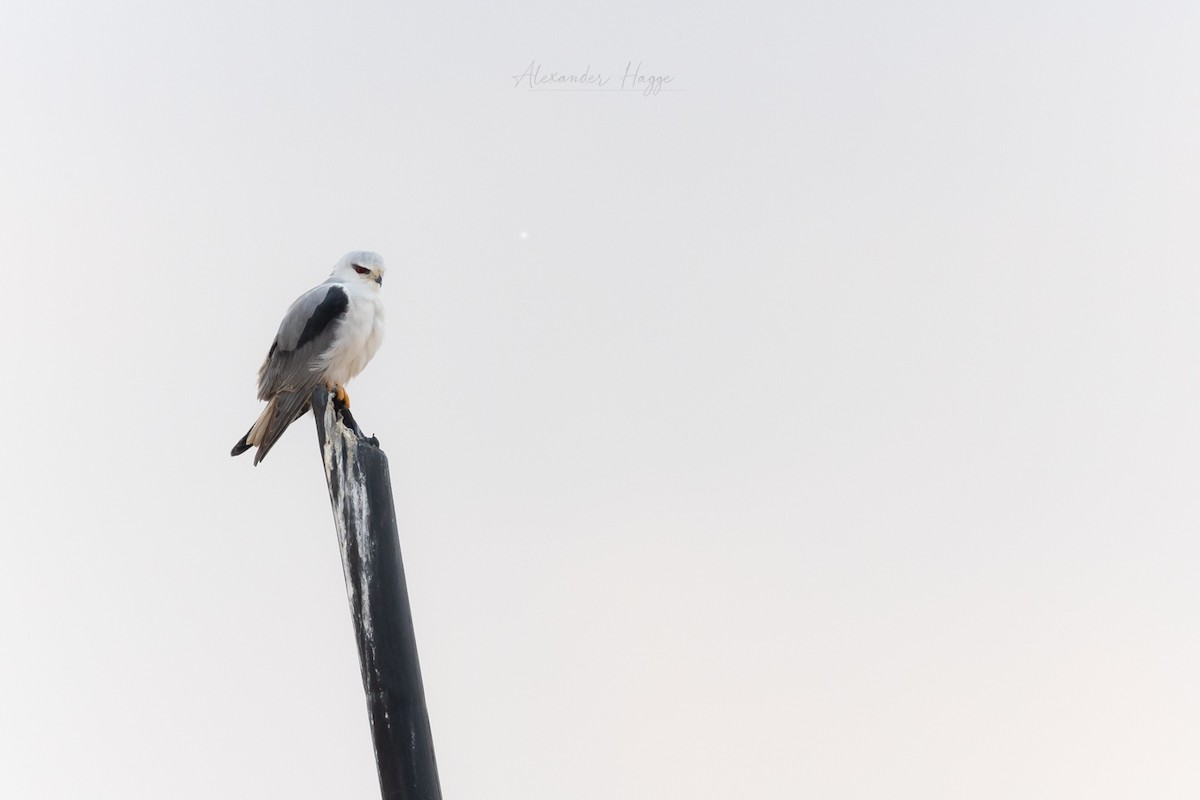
top-left (258, 283), bottom-right (350, 400)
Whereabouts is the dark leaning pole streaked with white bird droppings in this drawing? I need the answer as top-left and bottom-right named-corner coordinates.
top-left (312, 389), bottom-right (442, 800)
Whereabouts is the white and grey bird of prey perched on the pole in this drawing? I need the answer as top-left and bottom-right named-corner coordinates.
top-left (229, 251), bottom-right (388, 465)
